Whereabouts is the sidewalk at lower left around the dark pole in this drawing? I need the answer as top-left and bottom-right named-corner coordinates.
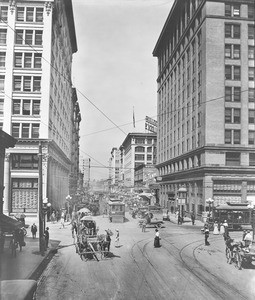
top-left (0, 220), bottom-right (60, 280)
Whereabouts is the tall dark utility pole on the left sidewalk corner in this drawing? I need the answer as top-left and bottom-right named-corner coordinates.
top-left (38, 142), bottom-right (44, 253)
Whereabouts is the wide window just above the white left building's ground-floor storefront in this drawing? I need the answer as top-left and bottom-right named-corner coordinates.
top-left (12, 154), bottom-right (38, 170)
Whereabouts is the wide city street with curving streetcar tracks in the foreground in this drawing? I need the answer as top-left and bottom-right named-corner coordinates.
top-left (34, 214), bottom-right (255, 300)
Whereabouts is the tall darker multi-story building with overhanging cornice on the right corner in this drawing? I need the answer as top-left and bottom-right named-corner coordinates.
top-left (153, 0), bottom-right (255, 215)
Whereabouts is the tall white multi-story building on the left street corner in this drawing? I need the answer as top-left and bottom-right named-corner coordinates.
top-left (0, 0), bottom-right (80, 215)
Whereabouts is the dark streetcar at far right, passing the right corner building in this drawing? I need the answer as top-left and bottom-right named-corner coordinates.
top-left (212, 202), bottom-right (252, 230)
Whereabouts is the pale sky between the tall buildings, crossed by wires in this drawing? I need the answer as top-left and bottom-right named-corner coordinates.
top-left (72, 0), bottom-right (173, 180)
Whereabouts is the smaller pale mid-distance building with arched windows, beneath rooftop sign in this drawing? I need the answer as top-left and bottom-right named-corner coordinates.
top-left (120, 133), bottom-right (157, 188)
